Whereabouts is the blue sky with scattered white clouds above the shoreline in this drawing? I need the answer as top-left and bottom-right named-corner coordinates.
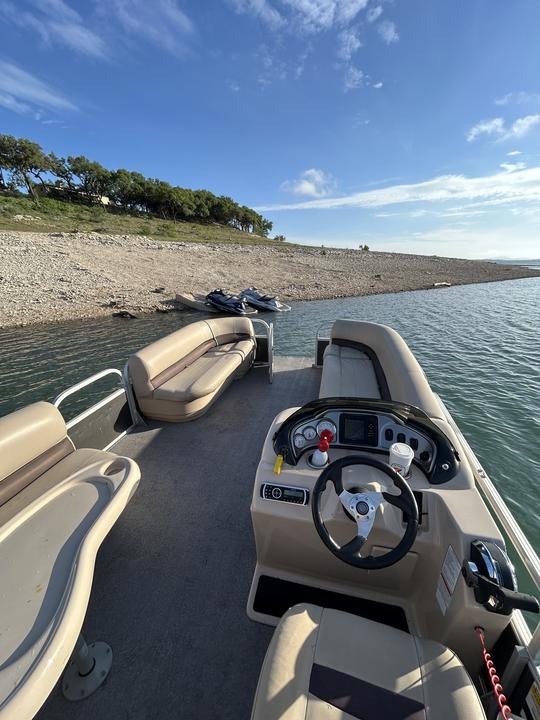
top-left (0, 0), bottom-right (540, 258)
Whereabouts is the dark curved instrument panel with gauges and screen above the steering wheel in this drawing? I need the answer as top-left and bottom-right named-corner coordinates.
top-left (273, 398), bottom-right (459, 484)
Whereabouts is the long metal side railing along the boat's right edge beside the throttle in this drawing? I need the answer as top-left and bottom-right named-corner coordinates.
top-left (437, 396), bottom-right (540, 659)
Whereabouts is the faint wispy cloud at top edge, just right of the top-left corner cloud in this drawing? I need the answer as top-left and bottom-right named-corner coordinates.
top-left (97, 0), bottom-right (195, 55)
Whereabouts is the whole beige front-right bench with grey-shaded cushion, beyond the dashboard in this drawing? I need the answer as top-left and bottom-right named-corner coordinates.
top-left (319, 320), bottom-right (442, 418)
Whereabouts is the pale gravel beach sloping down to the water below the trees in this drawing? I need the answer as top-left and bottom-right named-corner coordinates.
top-left (0, 232), bottom-right (540, 327)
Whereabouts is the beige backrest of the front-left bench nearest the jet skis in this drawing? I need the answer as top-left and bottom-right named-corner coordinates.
top-left (128, 317), bottom-right (253, 398)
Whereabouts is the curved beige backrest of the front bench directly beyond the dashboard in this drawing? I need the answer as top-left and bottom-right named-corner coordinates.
top-left (331, 320), bottom-right (442, 418)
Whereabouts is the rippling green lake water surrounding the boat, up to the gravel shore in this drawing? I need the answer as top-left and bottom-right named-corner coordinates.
top-left (0, 278), bottom-right (540, 572)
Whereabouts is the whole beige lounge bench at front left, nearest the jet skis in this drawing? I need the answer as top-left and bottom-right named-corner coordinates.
top-left (128, 317), bottom-right (255, 422)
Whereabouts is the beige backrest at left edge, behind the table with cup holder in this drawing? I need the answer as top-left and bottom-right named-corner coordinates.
top-left (0, 402), bottom-right (75, 505)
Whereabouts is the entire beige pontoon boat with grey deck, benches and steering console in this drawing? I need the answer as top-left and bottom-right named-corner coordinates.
top-left (0, 318), bottom-right (540, 720)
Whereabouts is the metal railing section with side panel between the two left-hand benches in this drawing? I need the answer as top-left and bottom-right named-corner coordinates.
top-left (53, 368), bottom-right (142, 450)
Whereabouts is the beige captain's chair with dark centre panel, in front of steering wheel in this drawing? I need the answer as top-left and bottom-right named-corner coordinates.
top-left (251, 605), bottom-right (486, 720)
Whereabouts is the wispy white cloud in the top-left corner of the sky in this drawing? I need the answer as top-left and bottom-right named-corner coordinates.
top-left (0, 0), bottom-right (107, 58)
